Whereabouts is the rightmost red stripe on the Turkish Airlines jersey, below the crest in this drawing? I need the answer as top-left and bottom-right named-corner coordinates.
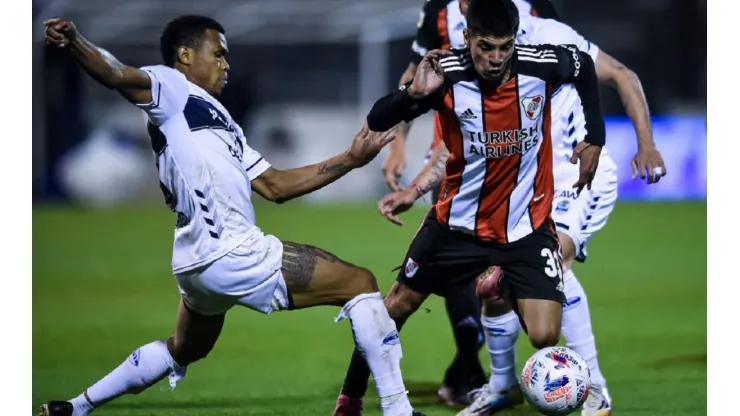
top-left (529, 85), bottom-right (555, 231)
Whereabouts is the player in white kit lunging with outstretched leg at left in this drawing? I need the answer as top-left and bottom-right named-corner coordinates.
top-left (41, 16), bottom-right (419, 416)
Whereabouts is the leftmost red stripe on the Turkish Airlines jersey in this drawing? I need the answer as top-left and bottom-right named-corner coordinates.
top-left (435, 89), bottom-right (465, 224)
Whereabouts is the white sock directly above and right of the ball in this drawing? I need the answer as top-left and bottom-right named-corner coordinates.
top-left (562, 270), bottom-right (606, 386)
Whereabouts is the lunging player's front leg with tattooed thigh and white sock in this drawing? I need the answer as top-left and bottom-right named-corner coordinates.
top-left (282, 242), bottom-right (423, 415)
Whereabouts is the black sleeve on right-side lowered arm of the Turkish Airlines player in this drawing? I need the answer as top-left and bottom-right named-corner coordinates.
top-left (550, 45), bottom-right (606, 146)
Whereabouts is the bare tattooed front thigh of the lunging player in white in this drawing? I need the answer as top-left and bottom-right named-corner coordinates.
top-left (281, 241), bottom-right (378, 309)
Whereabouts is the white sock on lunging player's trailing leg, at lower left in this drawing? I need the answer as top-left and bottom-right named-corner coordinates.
top-left (70, 341), bottom-right (187, 416)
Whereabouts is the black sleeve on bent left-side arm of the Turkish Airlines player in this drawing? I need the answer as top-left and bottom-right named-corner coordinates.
top-left (367, 80), bottom-right (449, 131)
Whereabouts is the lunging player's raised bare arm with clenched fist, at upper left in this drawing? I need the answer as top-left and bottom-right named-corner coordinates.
top-left (44, 18), bottom-right (152, 104)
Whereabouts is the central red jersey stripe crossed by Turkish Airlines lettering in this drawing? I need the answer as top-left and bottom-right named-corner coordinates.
top-left (476, 77), bottom-right (522, 243)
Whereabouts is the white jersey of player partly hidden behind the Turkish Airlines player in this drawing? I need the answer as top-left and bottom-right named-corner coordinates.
top-left (516, 17), bottom-right (616, 171)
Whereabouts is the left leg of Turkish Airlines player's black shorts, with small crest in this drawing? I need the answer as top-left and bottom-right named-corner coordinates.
top-left (396, 209), bottom-right (492, 297)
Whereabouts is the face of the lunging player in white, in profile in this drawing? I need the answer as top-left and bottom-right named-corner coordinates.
top-left (189, 29), bottom-right (229, 97)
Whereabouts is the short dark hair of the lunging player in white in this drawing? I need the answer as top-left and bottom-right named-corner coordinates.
top-left (159, 15), bottom-right (226, 67)
